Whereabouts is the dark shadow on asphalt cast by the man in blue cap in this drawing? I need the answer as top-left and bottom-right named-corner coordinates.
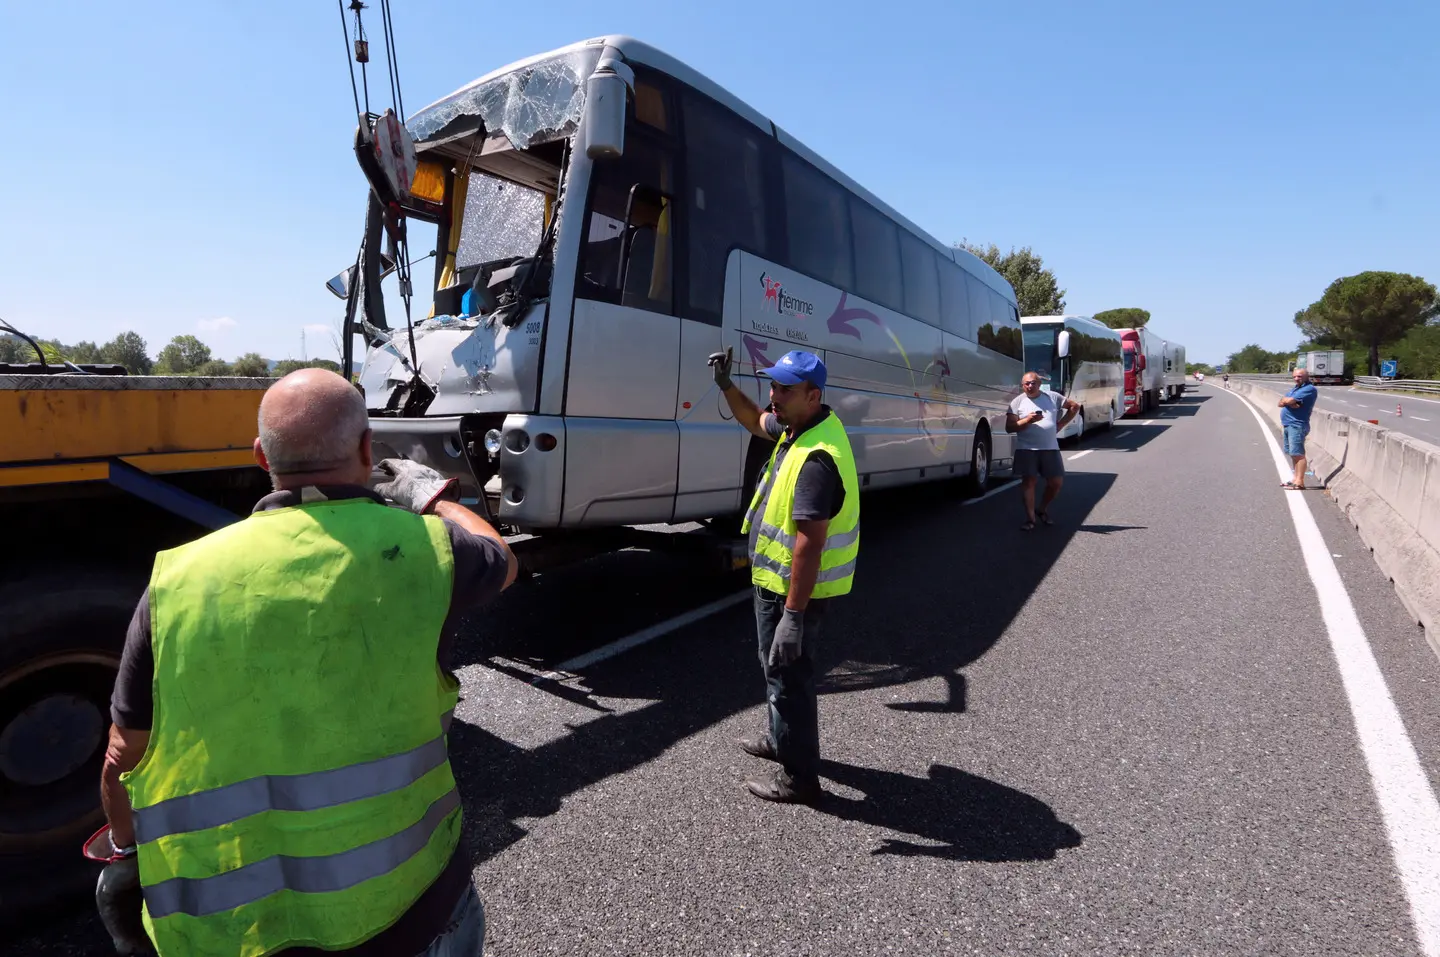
top-left (818, 761), bottom-right (1081, 863)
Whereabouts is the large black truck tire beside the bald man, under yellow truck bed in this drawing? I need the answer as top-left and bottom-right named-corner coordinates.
top-left (0, 570), bottom-right (144, 924)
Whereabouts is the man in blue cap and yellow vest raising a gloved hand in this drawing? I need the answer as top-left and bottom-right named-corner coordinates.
top-left (710, 351), bottom-right (860, 804)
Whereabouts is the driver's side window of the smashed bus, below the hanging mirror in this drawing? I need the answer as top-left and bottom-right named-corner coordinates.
top-left (576, 82), bottom-right (675, 314)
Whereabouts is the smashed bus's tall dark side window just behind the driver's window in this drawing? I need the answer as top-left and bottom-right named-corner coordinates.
top-left (683, 91), bottom-right (775, 324)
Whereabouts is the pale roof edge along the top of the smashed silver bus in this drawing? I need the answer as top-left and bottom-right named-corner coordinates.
top-left (412, 35), bottom-right (1015, 302)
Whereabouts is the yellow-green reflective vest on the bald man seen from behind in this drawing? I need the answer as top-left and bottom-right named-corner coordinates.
top-left (121, 499), bottom-right (461, 957)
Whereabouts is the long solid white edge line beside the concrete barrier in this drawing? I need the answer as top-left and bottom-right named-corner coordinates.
top-left (1236, 385), bottom-right (1440, 957)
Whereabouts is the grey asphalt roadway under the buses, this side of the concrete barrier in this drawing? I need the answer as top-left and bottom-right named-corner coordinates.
top-left (11, 384), bottom-right (1440, 957)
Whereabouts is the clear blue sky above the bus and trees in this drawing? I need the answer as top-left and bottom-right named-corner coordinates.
top-left (0, 0), bottom-right (1440, 361)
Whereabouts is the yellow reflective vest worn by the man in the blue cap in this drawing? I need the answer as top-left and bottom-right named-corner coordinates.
top-left (742, 413), bottom-right (860, 599)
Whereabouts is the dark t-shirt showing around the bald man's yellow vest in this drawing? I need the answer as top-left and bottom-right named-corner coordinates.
top-left (109, 485), bottom-right (508, 957)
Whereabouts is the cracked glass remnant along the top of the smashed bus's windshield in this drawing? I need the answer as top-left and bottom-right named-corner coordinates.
top-left (406, 46), bottom-right (600, 150)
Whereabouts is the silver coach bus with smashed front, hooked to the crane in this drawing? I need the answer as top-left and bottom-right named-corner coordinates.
top-left (348, 36), bottom-right (1022, 531)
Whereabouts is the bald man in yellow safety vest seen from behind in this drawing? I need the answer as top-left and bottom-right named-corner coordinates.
top-left (96, 370), bottom-right (516, 957)
